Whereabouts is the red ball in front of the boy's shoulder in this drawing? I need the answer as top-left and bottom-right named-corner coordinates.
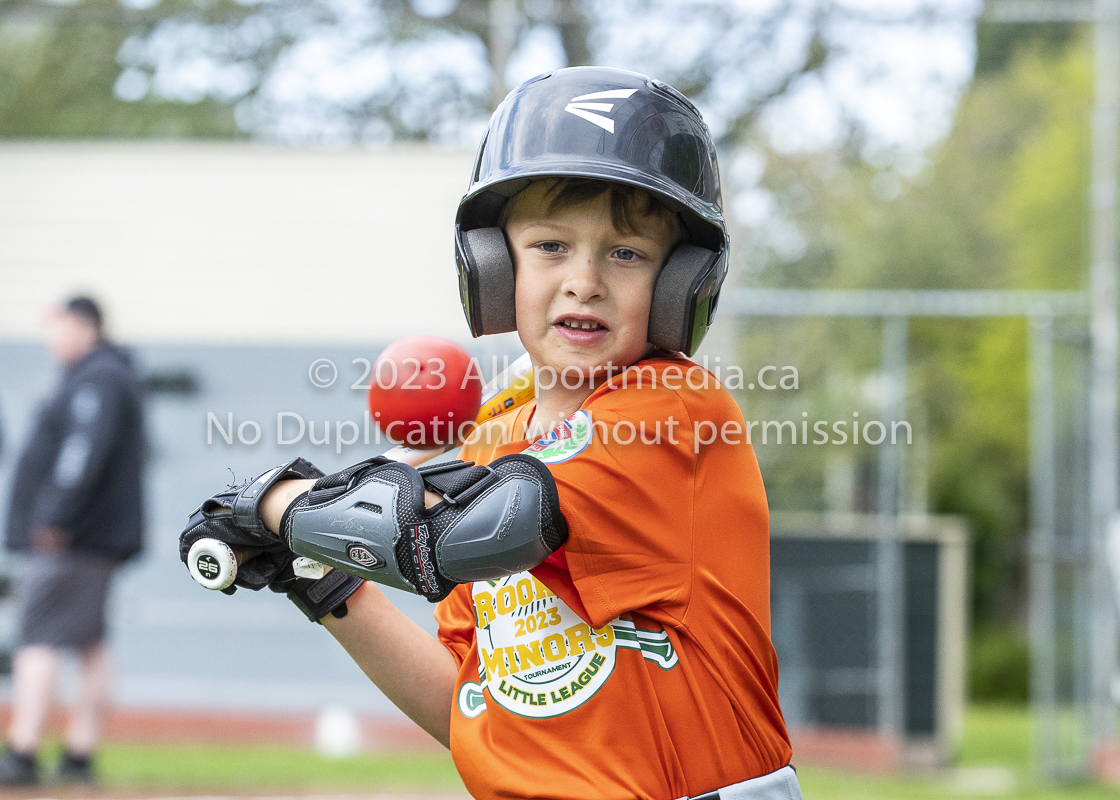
top-left (370, 336), bottom-right (483, 447)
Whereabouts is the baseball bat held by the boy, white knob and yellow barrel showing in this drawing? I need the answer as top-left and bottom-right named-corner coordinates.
top-left (187, 353), bottom-right (534, 590)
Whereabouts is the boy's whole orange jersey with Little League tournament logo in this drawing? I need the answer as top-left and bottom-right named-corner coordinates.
top-left (436, 359), bottom-right (791, 800)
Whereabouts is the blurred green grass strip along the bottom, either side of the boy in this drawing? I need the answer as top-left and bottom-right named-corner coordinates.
top-left (61, 706), bottom-right (1120, 800)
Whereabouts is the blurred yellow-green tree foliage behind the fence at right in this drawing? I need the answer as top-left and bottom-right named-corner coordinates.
top-left (748, 39), bottom-right (1092, 622)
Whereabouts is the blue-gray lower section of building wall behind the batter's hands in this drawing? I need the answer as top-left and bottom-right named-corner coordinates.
top-left (0, 343), bottom-right (515, 715)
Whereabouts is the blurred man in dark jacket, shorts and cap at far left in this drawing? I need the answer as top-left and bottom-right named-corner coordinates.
top-left (0, 297), bottom-right (143, 785)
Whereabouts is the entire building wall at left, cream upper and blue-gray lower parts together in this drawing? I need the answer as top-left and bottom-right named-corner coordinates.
top-left (0, 142), bottom-right (517, 714)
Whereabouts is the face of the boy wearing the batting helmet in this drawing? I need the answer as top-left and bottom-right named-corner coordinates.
top-left (505, 183), bottom-right (674, 387)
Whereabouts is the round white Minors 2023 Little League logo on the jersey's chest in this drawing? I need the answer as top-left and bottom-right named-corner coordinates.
top-left (473, 573), bottom-right (617, 719)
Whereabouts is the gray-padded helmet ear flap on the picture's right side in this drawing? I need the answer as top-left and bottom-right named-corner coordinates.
top-left (647, 244), bottom-right (722, 356)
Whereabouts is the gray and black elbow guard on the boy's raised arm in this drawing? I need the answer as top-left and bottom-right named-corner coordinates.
top-left (280, 455), bottom-right (568, 603)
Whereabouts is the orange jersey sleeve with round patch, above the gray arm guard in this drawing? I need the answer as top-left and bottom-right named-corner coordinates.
top-left (526, 376), bottom-right (712, 626)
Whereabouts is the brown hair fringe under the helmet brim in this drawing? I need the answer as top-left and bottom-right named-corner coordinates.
top-left (497, 172), bottom-right (684, 242)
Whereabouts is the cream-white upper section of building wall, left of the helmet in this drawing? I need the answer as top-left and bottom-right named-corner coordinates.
top-left (0, 142), bottom-right (472, 344)
